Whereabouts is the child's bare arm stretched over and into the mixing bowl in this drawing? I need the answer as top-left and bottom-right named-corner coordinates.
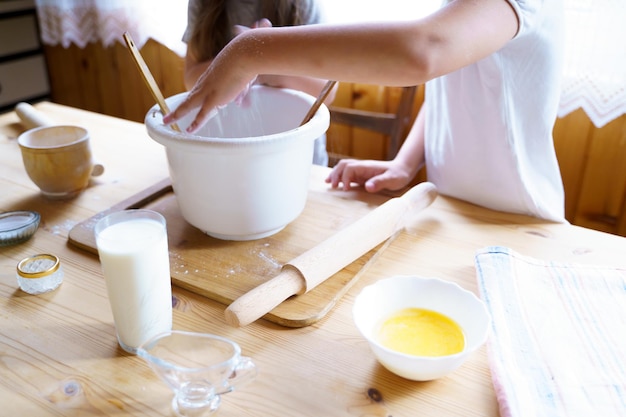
top-left (165, 0), bottom-right (518, 131)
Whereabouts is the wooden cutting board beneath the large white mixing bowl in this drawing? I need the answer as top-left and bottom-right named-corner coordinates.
top-left (69, 175), bottom-right (389, 327)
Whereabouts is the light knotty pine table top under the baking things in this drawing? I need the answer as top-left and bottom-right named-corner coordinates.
top-left (0, 103), bottom-right (626, 417)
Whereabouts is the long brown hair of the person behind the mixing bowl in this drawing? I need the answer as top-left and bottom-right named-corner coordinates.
top-left (188, 0), bottom-right (313, 61)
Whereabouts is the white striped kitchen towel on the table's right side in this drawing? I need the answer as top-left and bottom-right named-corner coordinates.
top-left (475, 247), bottom-right (626, 417)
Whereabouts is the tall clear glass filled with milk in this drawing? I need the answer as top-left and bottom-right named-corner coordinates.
top-left (94, 209), bottom-right (172, 353)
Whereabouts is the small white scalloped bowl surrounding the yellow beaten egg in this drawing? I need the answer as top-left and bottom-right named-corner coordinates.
top-left (353, 276), bottom-right (491, 381)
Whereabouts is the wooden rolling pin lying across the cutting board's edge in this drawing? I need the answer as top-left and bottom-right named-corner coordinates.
top-left (225, 182), bottom-right (437, 326)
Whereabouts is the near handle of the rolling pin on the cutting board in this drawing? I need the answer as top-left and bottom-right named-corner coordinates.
top-left (224, 265), bottom-right (306, 327)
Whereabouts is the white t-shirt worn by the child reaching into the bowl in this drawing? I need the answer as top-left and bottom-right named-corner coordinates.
top-left (425, 0), bottom-right (566, 222)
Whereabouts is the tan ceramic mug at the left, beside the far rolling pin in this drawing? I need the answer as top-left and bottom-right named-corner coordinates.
top-left (17, 126), bottom-right (103, 199)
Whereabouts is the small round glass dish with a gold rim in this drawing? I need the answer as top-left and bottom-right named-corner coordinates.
top-left (17, 254), bottom-right (63, 294)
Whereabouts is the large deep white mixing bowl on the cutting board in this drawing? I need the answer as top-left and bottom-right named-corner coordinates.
top-left (145, 86), bottom-right (330, 240)
